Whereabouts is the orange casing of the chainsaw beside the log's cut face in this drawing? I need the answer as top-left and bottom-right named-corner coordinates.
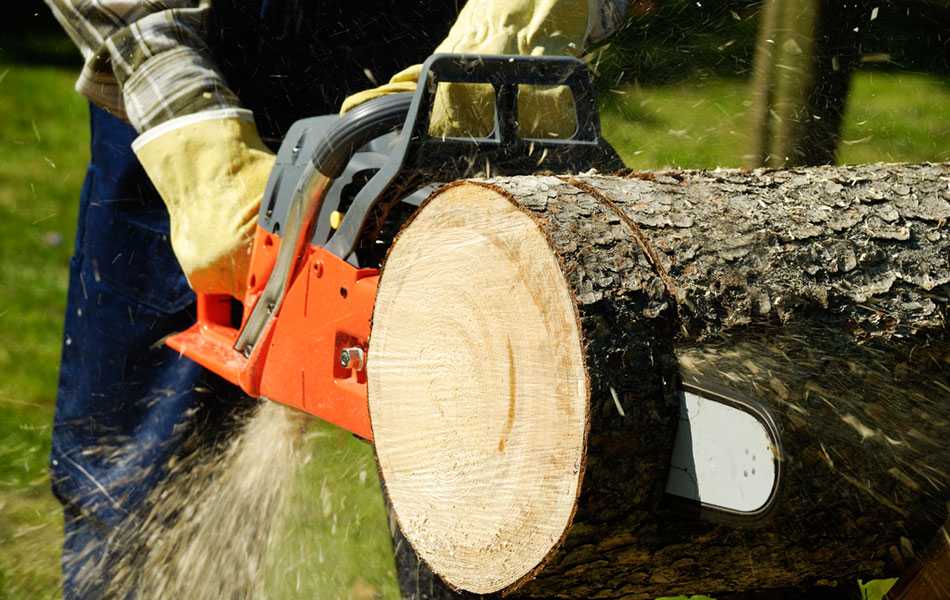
top-left (166, 227), bottom-right (379, 440)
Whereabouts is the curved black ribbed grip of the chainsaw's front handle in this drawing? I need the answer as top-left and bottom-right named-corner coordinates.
top-left (312, 92), bottom-right (412, 179)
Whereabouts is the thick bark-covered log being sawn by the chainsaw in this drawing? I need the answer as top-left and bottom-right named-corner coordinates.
top-left (367, 164), bottom-right (950, 600)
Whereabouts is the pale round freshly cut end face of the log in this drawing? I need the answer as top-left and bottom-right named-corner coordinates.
top-left (367, 184), bottom-right (589, 593)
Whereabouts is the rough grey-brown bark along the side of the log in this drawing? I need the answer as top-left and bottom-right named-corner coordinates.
top-left (369, 164), bottom-right (950, 600)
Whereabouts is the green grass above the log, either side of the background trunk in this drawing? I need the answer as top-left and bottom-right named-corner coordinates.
top-left (601, 72), bottom-right (950, 169)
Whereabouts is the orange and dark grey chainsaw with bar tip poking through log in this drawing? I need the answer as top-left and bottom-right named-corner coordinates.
top-left (166, 54), bottom-right (781, 523)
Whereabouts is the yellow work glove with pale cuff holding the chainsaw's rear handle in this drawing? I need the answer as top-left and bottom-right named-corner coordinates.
top-left (132, 110), bottom-right (274, 298)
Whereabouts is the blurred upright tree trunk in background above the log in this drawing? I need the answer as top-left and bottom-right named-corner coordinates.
top-left (746, 0), bottom-right (870, 167)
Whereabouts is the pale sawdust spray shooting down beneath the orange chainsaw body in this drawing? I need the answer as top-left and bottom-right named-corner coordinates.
top-left (97, 402), bottom-right (305, 599)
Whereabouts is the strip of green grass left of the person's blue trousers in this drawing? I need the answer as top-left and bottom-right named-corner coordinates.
top-left (0, 57), bottom-right (88, 598)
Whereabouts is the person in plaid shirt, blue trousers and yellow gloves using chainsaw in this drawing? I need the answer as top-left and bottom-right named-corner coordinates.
top-left (46, 0), bottom-right (627, 598)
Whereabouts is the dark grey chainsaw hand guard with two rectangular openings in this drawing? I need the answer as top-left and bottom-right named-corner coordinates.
top-left (325, 54), bottom-right (608, 260)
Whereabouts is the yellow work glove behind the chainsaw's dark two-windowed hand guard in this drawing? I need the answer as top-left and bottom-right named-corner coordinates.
top-left (341, 0), bottom-right (603, 138)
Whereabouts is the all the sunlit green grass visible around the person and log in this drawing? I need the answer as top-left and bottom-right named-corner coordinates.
top-left (0, 49), bottom-right (950, 599)
